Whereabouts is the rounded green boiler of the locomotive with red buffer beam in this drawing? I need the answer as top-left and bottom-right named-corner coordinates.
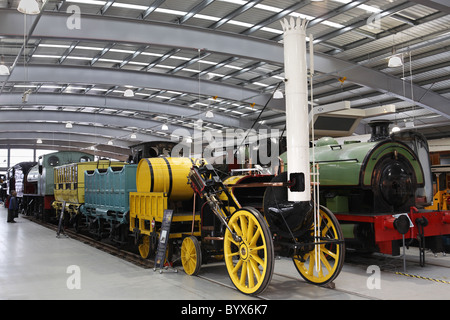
top-left (308, 121), bottom-right (430, 213)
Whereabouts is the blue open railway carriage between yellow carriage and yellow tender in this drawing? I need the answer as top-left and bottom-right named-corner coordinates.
top-left (80, 164), bottom-right (137, 243)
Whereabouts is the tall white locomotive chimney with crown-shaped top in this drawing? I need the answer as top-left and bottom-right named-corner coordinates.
top-left (281, 18), bottom-right (311, 201)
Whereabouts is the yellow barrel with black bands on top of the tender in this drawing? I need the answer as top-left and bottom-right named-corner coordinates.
top-left (136, 157), bottom-right (194, 201)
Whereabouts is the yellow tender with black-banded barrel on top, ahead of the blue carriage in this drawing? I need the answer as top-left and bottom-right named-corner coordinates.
top-left (130, 157), bottom-right (201, 258)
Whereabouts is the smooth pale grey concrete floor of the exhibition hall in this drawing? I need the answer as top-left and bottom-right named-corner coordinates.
top-left (0, 208), bottom-right (450, 301)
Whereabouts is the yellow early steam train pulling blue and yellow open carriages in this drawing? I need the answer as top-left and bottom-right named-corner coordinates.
top-left (5, 140), bottom-right (345, 295)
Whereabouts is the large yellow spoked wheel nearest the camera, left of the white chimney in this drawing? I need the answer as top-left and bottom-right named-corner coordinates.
top-left (223, 207), bottom-right (274, 295)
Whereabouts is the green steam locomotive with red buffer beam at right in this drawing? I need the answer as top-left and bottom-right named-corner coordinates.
top-left (281, 121), bottom-right (450, 256)
